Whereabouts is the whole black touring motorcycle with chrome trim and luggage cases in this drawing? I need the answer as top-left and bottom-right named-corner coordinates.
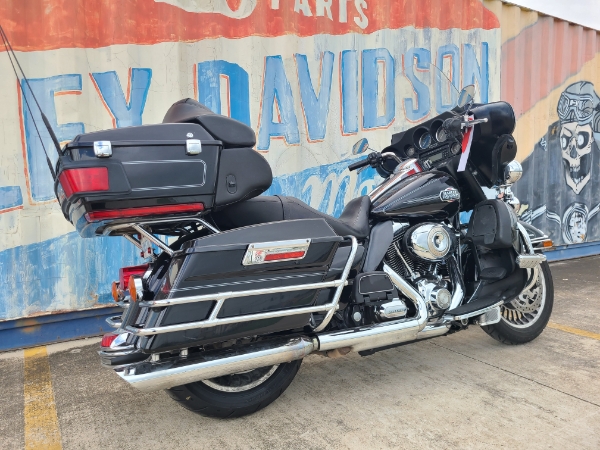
top-left (53, 71), bottom-right (553, 417)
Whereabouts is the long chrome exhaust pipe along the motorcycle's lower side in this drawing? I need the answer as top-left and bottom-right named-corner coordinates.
top-left (117, 270), bottom-right (448, 392)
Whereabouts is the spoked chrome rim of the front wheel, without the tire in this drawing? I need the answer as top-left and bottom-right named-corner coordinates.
top-left (500, 266), bottom-right (546, 328)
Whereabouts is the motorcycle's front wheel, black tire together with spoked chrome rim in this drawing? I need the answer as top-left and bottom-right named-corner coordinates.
top-left (481, 261), bottom-right (554, 345)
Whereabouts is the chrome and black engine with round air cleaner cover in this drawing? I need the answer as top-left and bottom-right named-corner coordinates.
top-left (384, 222), bottom-right (457, 318)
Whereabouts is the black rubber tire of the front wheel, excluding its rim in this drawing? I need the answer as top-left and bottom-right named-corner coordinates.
top-left (481, 261), bottom-right (554, 345)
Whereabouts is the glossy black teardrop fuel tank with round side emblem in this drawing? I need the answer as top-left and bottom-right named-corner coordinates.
top-left (371, 171), bottom-right (460, 220)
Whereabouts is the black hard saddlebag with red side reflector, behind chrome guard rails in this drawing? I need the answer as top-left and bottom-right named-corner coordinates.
top-left (140, 219), bottom-right (342, 352)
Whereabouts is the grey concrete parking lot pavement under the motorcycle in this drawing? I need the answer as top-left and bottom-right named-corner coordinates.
top-left (0, 257), bottom-right (600, 450)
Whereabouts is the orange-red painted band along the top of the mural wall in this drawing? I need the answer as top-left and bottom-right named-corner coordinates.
top-left (0, 0), bottom-right (500, 51)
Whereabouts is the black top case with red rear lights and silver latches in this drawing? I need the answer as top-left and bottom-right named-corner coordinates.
top-left (55, 123), bottom-right (272, 237)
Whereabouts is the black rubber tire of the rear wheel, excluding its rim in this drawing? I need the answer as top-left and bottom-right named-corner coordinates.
top-left (167, 359), bottom-right (302, 418)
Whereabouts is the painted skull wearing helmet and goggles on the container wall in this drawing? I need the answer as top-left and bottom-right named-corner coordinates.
top-left (557, 81), bottom-right (600, 194)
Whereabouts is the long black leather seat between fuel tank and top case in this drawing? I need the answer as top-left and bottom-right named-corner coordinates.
top-left (212, 195), bottom-right (371, 239)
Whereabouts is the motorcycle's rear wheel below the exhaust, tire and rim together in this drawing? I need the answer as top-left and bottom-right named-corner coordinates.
top-left (167, 360), bottom-right (302, 418)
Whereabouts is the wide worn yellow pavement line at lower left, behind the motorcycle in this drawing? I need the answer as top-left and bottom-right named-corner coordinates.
top-left (24, 347), bottom-right (62, 450)
